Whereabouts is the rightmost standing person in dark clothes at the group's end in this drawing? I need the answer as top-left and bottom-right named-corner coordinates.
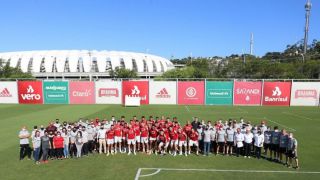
top-left (287, 133), bottom-right (299, 169)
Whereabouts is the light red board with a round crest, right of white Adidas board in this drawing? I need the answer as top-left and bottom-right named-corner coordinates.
top-left (178, 81), bottom-right (204, 104)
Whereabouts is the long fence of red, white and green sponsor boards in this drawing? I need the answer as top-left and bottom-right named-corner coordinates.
top-left (0, 79), bottom-right (320, 106)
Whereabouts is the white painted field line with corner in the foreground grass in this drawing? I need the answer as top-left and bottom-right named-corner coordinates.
top-left (135, 168), bottom-right (320, 180)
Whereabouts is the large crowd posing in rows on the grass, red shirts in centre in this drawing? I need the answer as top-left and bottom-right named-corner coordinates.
top-left (19, 116), bottom-right (299, 168)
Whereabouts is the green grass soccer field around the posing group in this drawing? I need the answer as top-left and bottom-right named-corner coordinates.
top-left (0, 105), bottom-right (320, 180)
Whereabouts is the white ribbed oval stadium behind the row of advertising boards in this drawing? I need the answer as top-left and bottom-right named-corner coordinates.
top-left (0, 50), bottom-right (174, 78)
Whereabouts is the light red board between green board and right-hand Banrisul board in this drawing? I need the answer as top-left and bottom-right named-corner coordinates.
top-left (233, 81), bottom-right (262, 105)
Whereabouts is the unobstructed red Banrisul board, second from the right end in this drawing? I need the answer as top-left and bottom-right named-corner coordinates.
top-left (262, 82), bottom-right (291, 106)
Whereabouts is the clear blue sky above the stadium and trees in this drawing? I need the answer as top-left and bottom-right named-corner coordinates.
top-left (0, 0), bottom-right (320, 58)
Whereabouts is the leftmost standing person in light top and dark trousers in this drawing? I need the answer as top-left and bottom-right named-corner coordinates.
top-left (18, 126), bottom-right (31, 160)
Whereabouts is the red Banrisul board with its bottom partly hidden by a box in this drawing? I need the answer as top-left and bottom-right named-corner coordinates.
top-left (122, 81), bottom-right (149, 104)
